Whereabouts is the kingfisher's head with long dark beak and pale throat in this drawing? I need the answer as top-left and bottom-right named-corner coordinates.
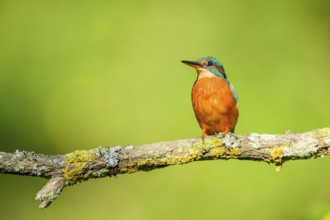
top-left (181, 57), bottom-right (227, 79)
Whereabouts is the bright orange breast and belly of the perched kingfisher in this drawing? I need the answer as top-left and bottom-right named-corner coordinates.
top-left (191, 77), bottom-right (238, 137)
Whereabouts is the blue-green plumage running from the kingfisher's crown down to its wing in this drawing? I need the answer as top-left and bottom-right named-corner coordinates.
top-left (196, 57), bottom-right (238, 103)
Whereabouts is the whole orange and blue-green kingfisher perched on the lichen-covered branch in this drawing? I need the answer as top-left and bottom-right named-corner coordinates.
top-left (181, 57), bottom-right (238, 138)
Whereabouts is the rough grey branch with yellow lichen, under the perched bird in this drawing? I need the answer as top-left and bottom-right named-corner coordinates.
top-left (0, 128), bottom-right (330, 208)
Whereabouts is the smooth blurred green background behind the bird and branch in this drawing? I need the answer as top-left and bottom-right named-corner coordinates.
top-left (0, 0), bottom-right (330, 220)
